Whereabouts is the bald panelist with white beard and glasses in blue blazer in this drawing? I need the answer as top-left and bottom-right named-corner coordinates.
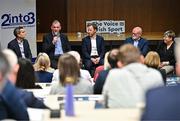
top-left (124, 27), bottom-right (149, 57)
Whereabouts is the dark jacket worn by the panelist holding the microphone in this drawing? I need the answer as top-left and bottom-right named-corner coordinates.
top-left (42, 33), bottom-right (71, 58)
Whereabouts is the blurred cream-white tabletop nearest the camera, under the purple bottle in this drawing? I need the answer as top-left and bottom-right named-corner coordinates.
top-left (28, 101), bottom-right (142, 121)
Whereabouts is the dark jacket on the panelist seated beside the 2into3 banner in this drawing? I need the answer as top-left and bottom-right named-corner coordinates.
top-left (8, 39), bottom-right (32, 60)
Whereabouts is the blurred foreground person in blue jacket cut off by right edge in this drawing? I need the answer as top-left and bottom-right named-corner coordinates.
top-left (142, 41), bottom-right (180, 121)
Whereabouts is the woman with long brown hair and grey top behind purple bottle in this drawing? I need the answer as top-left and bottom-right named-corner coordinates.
top-left (50, 53), bottom-right (93, 94)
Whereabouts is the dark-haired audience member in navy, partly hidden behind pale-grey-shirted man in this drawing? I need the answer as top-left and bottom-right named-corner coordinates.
top-left (94, 49), bottom-right (118, 94)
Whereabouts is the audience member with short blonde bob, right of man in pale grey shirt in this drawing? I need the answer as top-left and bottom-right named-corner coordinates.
top-left (144, 51), bottom-right (166, 84)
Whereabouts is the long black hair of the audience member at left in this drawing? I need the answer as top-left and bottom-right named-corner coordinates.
top-left (16, 58), bottom-right (36, 89)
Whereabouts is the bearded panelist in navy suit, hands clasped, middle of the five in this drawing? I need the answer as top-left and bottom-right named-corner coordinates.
top-left (82, 23), bottom-right (104, 76)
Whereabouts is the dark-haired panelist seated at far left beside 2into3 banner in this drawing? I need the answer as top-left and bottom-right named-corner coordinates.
top-left (8, 26), bottom-right (32, 60)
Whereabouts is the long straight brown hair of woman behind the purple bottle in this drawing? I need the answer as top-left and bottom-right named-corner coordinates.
top-left (58, 53), bottom-right (80, 86)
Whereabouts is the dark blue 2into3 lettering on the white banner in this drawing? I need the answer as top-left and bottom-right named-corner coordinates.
top-left (1, 12), bottom-right (35, 27)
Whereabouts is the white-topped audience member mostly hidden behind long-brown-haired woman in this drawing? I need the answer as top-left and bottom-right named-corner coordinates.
top-left (52, 51), bottom-right (93, 83)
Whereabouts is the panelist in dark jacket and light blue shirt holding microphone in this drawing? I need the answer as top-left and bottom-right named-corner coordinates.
top-left (42, 20), bottom-right (71, 69)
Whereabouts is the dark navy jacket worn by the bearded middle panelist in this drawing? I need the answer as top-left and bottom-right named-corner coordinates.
top-left (82, 35), bottom-right (104, 60)
